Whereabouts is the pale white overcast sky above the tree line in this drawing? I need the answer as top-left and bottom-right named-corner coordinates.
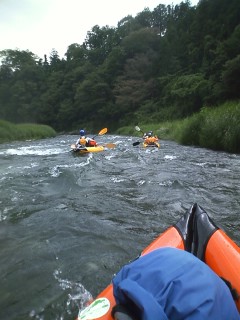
top-left (0, 0), bottom-right (198, 58)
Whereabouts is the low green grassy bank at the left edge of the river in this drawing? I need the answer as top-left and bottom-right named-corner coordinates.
top-left (0, 120), bottom-right (56, 143)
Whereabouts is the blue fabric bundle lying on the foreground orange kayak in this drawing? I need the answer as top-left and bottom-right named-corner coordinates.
top-left (113, 248), bottom-right (240, 320)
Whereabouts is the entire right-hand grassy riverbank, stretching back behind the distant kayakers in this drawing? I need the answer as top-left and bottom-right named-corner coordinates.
top-left (118, 102), bottom-right (240, 153)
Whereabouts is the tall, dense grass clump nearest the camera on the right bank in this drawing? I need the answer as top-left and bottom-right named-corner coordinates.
top-left (176, 103), bottom-right (240, 153)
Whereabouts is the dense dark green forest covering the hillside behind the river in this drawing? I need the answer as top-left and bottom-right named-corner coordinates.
top-left (0, 0), bottom-right (240, 132)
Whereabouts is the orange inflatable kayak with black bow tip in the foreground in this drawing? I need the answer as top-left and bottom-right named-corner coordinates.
top-left (77, 204), bottom-right (240, 320)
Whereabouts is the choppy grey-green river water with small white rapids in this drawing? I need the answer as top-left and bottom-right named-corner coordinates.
top-left (0, 135), bottom-right (240, 320)
